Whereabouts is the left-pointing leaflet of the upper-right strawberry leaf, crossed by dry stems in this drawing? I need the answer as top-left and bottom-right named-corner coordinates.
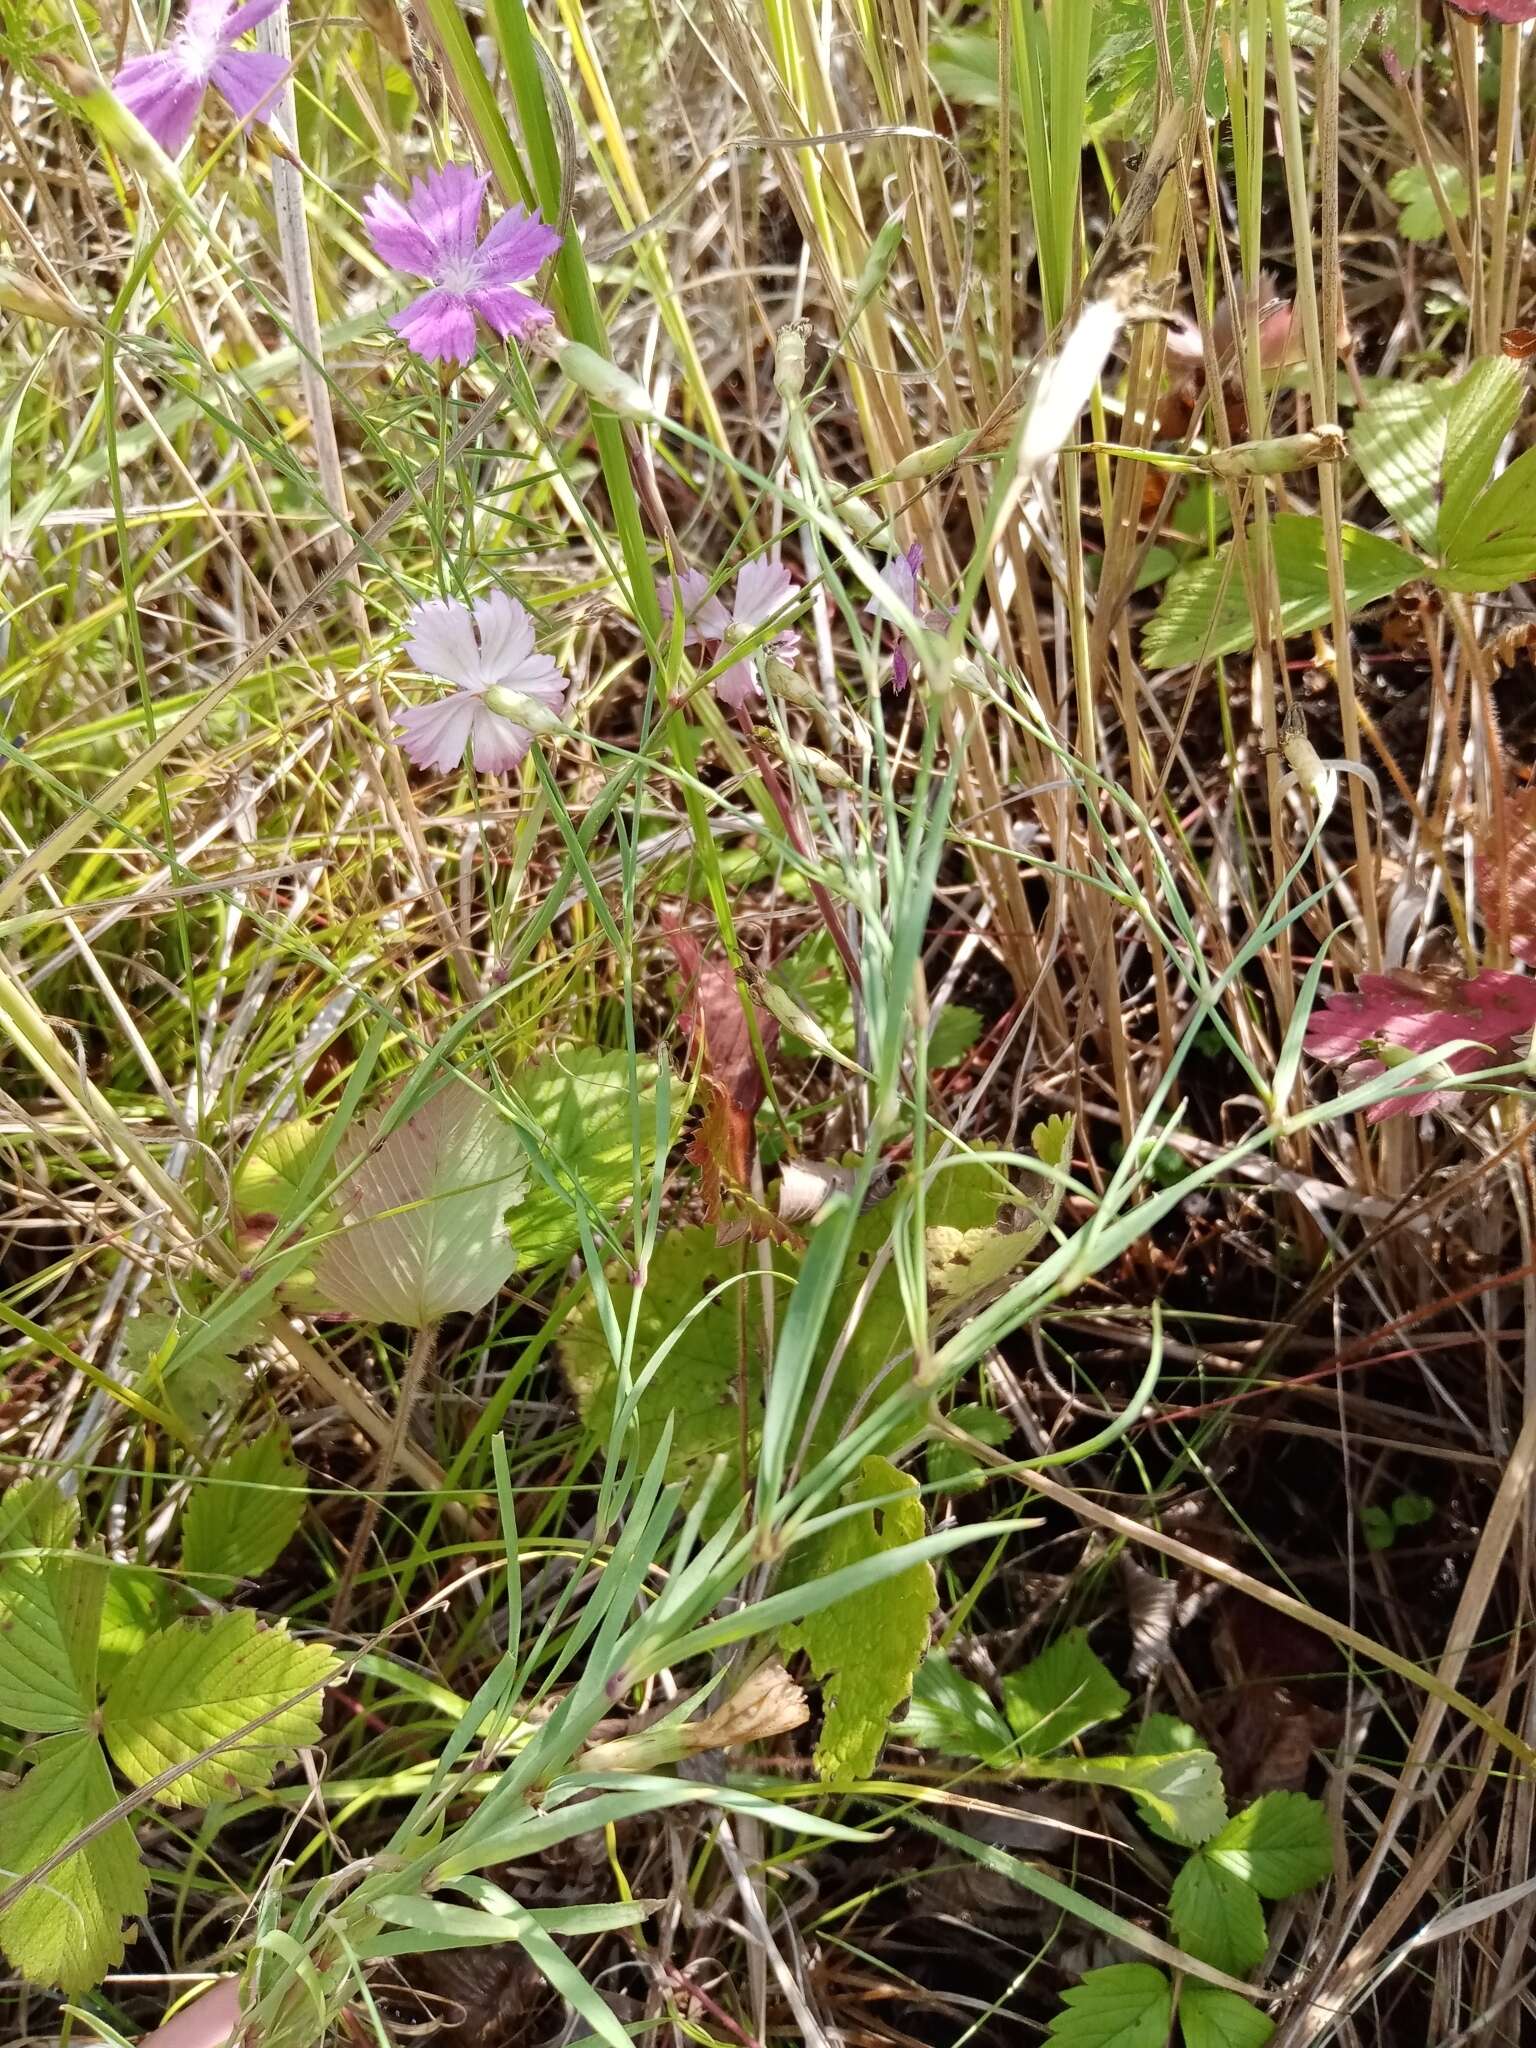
top-left (1143, 512), bottom-right (1423, 668)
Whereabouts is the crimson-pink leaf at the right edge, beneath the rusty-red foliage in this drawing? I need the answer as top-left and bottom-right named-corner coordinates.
top-left (1307, 969), bottom-right (1536, 1124)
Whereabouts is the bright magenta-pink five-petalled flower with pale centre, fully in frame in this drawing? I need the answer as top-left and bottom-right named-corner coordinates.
top-left (362, 164), bottom-right (561, 362)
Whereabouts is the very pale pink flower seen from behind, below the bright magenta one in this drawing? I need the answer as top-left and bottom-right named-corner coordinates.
top-left (399, 590), bottom-right (567, 774)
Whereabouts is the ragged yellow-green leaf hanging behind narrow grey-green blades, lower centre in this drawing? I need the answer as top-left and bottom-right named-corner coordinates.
top-left (780, 1458), bottom-right (938, 1778)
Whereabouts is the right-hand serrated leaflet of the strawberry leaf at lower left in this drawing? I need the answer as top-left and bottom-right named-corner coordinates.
top-left (102, 1608), bottom-right (338, 1806)
